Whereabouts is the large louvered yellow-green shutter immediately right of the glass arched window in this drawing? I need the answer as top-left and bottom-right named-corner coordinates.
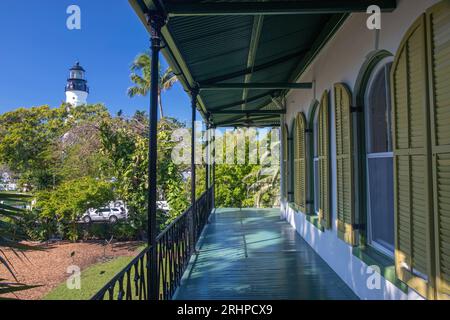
top-left (391, 15), bottom-right (432, 297)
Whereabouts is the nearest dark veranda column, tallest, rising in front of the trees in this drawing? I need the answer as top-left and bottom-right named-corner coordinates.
top-left (147, 13), bottom-right (164, 300)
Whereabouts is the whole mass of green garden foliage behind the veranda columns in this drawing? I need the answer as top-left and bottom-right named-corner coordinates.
top-left (0, 105), bottom-right (279, 239)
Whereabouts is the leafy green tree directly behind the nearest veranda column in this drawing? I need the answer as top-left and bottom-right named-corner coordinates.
top-left (101, 113), bottom-right (188, 230)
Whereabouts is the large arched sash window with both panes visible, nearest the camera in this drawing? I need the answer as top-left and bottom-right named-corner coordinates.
top-left (365, 59), bottom-right (394, 256)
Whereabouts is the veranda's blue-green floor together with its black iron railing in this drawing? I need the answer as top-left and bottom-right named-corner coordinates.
top-left (93, 188), bottom-right (357, 300)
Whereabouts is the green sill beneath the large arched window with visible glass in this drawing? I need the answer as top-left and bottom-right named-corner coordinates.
top-left (352, 246), bottom-right (409, 293)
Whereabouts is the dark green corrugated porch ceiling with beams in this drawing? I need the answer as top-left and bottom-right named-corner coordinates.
top-left (129, 0), bottom-right (396, 126)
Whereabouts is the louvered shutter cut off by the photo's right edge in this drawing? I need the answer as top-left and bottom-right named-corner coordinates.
top-left (427, 1), bottom-right (450, 299)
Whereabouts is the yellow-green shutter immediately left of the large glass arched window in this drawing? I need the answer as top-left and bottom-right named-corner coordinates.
top-left (334, 83), bottom-right (357, 245)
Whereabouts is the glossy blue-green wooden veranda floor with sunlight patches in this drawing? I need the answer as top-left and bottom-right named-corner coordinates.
top-left (175, 209), bottom-right (357, 300)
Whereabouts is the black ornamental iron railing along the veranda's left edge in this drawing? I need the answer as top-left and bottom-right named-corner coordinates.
top-left (92, 187), bottom-right (214, 300)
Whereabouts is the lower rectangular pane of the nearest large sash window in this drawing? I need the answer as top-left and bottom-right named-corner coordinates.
top-left (368, 157), bottom-right (394, 252)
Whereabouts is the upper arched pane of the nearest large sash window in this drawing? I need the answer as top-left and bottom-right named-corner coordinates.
top-left (367, 65), bottom-right (392, 153)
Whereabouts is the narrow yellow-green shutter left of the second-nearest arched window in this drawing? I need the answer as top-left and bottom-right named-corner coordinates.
top-left (294, 113), bottom-right (306, 213)
